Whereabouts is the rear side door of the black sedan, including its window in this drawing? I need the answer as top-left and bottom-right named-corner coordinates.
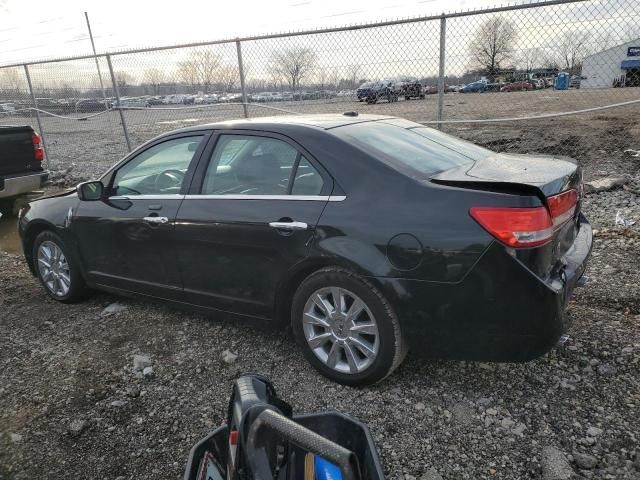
top-left (176, 131), bottom-right (333, 318)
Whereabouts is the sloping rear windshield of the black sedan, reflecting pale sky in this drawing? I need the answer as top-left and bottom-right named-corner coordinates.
top-left (334, 121), bottom-right (484, 177)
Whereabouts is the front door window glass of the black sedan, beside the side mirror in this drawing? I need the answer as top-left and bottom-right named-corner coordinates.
top-left (111, 135), bottom-right (202, 196)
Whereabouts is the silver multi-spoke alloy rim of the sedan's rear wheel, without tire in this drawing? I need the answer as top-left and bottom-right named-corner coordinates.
top-left (302, 287), bottom-right (380, 374)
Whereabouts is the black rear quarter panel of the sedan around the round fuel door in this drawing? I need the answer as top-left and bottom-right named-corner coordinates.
top-left (299, 132), bottom-right (540, 282)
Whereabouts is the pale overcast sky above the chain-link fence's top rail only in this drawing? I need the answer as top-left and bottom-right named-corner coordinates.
top-left (0, 0), bottom-right (524, 65)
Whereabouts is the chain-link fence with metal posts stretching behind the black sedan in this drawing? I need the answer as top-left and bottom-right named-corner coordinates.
top-left (0, 0), bottom-right (640, 183)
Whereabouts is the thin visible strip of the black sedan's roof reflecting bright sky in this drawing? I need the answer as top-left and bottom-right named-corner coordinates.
top-left (172, 113), bottom-right (396, 132)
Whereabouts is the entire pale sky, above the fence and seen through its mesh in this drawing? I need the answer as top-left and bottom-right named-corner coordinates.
top-left (0, 0), bottom-right (640, 90)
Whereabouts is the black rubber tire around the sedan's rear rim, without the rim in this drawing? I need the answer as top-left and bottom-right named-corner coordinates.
top-left (291, 269), bottom-right (401, 386)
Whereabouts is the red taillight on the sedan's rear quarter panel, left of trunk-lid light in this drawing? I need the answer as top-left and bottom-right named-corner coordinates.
top-left (469, 207), bottom-right (553, 247)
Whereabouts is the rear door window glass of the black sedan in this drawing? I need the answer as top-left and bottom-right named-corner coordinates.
top-left (202, 135), bottom-right (322, 195)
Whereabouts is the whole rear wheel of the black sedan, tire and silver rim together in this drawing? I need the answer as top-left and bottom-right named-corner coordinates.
top-left (291, 267), bottom-right (407, 386)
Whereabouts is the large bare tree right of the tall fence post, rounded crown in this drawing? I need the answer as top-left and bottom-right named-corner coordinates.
top-left (469, 15), bottom-right (518, 77)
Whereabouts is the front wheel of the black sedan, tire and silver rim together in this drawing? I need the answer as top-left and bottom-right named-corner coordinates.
top-left (31, 230), bottom-right (87, 303)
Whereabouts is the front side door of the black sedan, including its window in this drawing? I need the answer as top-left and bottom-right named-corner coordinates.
top-left (71, 132), bottom-right (206, 299)
